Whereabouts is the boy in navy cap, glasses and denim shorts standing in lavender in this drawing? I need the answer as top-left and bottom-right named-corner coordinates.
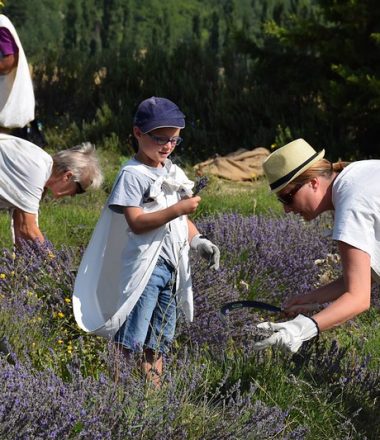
top-left (108, 97), bottom-right (219, 385)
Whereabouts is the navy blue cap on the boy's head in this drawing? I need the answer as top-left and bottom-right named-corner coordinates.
top-left (133, 96), bottom-right (185, 133)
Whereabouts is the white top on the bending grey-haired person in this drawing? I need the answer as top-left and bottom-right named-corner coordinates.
top-left (0, 134), bottom-right (53, 214)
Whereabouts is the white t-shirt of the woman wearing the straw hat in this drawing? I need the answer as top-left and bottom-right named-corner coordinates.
top-left (332, 160), bottom-right (380, 282)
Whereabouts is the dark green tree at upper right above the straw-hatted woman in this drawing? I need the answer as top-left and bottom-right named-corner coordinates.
top-left (254, 0), bottom-right (380, 159)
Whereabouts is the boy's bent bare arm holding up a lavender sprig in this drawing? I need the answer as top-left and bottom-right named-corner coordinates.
top-left (123, 196), bottom-right (201, 234)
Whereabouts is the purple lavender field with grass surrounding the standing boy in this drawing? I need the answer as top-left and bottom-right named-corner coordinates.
top-left (0, 214), bottom-right (380, 440)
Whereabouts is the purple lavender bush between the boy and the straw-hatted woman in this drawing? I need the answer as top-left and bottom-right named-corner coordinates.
top-left (181, 214), bottom-right (339, 350)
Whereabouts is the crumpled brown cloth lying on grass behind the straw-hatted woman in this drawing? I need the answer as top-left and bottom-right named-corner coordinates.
top-left (194, 147), bottom-right (270, 182)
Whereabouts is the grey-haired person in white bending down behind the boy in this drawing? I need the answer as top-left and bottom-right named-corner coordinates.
top-left (0, 133), bottom-right (103, 243)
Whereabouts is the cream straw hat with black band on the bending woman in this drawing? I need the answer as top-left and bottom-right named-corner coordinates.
top-left (263, 139), bottom-right (325, 192)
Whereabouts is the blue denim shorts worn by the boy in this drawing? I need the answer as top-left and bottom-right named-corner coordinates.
top-left (114, 257), bottom-right (177, 353)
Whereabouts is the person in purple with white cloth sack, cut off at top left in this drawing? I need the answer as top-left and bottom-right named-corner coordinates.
top-left (0, 14), bottom-right (35, 134)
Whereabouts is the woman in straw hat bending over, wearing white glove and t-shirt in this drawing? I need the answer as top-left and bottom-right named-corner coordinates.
top-left (255, 139), bottom-right (380, 353)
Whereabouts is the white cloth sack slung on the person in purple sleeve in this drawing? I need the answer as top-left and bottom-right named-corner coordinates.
top-left (0, 14), bottom-right (35, 128)
